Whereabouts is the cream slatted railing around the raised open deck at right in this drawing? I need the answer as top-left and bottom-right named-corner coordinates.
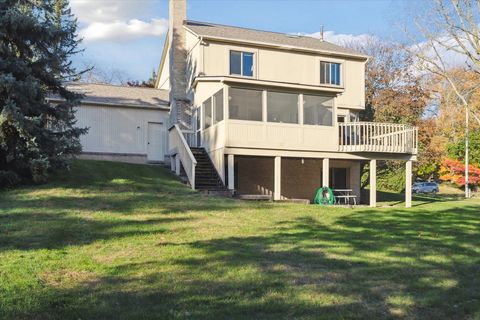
top-left (338, 122), bottom-right (418, 154)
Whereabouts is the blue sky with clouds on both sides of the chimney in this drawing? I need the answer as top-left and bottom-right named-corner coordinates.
top-left (70, 0), bottom-right (414, 80)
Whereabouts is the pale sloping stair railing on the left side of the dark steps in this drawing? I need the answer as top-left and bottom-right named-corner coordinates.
top-left (168, 124), bottom-right (197, 189)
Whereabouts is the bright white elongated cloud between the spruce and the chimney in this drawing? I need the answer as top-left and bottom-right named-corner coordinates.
top-left (79, 19), bottom-right (168, 41)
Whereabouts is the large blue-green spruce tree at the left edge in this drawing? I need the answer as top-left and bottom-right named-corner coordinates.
top-left (0, 0), bottom-right (86, 186)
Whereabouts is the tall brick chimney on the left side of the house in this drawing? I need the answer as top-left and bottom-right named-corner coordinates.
top-left (168, 0), bottom-right (192, 129)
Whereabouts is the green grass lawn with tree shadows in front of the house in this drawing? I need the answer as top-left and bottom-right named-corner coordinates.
top-left (0, 161), bottom-right (480, 319)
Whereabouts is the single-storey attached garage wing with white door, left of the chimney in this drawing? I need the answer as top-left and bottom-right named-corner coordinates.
top-left (50, 83), bottom-right (169, 163)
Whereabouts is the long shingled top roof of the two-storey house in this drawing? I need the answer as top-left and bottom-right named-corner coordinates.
top-left (185, 20), bottom-right (368, 59)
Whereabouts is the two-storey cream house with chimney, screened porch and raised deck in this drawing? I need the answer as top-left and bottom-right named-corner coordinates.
top-left (156, 0), bottom-right (417, 207)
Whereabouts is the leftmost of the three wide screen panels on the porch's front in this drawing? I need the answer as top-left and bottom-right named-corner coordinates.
top-left (228, 88), bottom-right (262, 121)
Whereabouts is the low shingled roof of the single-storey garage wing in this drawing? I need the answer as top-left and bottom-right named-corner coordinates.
top-left (50, 82), bottom-right (169, 109)
